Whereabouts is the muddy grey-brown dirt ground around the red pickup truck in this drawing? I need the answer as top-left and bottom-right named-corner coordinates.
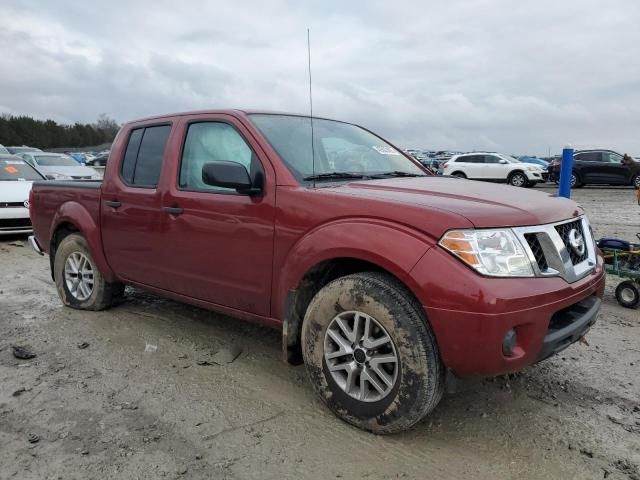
top-left (0, 187), bottom-right (640, 480)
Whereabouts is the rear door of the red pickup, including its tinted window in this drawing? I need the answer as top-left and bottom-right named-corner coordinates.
top-left (101, 123), bottom-right (171, 287)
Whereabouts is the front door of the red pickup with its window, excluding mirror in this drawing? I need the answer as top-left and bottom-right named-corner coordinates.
top-left (158, 115), bottom-right (275, 316)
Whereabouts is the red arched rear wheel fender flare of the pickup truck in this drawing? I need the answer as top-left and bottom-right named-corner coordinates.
top-left (49, 201), bottom-right (117, 282)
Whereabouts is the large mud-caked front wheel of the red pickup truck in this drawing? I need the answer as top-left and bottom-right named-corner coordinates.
top-left (302, 272), bottom-right (444, 434)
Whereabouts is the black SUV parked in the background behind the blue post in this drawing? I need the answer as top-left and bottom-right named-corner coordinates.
top-left (549, 150), bottom-right (640, 188)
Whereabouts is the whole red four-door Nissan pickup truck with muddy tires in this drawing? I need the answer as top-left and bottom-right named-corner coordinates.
top-left (30, 110), bottom-right (604, 433)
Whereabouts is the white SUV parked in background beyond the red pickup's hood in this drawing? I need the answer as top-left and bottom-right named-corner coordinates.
top-left (442, 152), bottom-right (545, 187)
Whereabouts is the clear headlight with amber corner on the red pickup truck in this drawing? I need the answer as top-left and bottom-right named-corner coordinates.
top-left (439, 229), bottom-right (534, 277)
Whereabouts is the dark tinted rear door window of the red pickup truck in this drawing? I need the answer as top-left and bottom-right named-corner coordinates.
top-left (120, 125), bottom-right (171, 187)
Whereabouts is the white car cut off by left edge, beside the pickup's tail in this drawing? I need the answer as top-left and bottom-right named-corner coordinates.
top-left (0, 155), bottom-right (45, 235)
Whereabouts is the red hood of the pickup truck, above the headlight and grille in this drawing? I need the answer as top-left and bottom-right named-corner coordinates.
top-left (330, 176), bottom-right (584, 228)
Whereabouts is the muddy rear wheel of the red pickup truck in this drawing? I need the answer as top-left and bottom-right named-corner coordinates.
top-left (53, 233), bottom-right (124, 310)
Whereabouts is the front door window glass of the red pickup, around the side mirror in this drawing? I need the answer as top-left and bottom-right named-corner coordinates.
top-left (178, 122), bottom-right (258, 192)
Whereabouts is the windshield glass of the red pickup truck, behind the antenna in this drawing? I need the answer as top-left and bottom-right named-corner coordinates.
top-left (251, 114), bottom-right (425, 181)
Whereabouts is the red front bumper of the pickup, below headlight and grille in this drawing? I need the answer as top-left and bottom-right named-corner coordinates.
top-left (411, 248), bottom-right (604, 378)
